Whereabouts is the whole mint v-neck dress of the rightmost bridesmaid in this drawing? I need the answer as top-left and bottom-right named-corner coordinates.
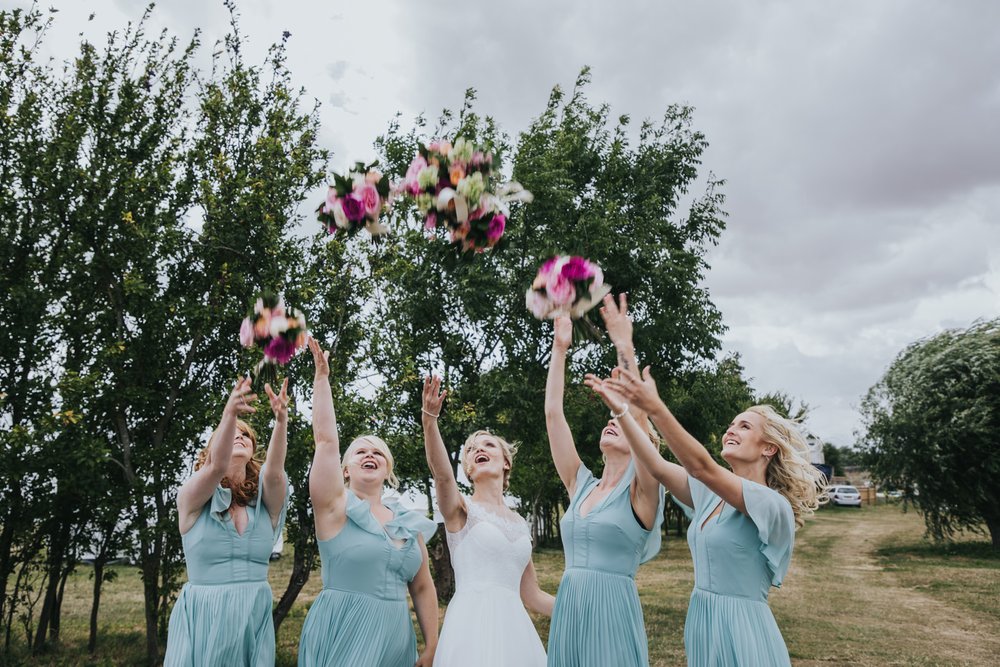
top-left (675, 477), bottom-right (795, 667)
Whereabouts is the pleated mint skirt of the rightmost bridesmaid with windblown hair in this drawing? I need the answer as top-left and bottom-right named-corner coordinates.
top-left (684, 588), bottom-right (791, 667)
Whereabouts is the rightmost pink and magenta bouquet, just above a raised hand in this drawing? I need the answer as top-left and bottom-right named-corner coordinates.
top-left (525, 255), bottom-right (611, 334)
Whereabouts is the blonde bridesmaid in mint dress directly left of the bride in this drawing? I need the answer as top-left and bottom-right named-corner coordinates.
top-left (299, 339), bottom-right (438, 667)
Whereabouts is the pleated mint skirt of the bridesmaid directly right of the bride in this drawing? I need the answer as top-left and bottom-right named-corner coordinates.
top-left (548, 568), bottom-right (649, 667)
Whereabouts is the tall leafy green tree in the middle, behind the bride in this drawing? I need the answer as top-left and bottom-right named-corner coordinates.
top-left (369, 70), bottom-right (725, 596)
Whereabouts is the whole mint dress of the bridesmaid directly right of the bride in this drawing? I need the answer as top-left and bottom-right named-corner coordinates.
top-left (548, 461), bottom-right (664, 667)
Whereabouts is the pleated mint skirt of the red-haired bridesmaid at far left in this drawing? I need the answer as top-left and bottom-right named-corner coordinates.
top-left (163, 581), bottom-right (274, 667)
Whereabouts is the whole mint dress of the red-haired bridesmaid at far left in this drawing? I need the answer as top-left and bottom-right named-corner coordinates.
top-left (163, 470), bottom-right (288, 667)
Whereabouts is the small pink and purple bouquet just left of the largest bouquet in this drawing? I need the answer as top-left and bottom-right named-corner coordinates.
top-left (316, 162), bottom-right (391, 238)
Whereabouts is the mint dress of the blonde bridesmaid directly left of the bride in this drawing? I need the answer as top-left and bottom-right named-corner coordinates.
top-left (299, 490), bottom-right (437, 667)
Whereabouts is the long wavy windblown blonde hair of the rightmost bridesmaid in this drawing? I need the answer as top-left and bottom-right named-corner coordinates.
top-left (747, 405), bottom-right (827, 528)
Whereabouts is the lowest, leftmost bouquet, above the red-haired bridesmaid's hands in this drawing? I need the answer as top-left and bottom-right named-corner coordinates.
top-left (240, 291), bottom-right (307, 382)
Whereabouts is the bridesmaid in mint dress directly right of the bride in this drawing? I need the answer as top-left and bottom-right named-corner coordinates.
top-left (545, 317), bottom-right (663, 667)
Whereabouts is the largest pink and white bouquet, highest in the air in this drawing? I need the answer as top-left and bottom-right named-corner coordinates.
top-left (395, 137), bottom-right (532, 252)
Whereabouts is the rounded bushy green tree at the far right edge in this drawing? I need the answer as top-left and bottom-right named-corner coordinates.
top-left (861, 319), bottom-right (1000, 550)
